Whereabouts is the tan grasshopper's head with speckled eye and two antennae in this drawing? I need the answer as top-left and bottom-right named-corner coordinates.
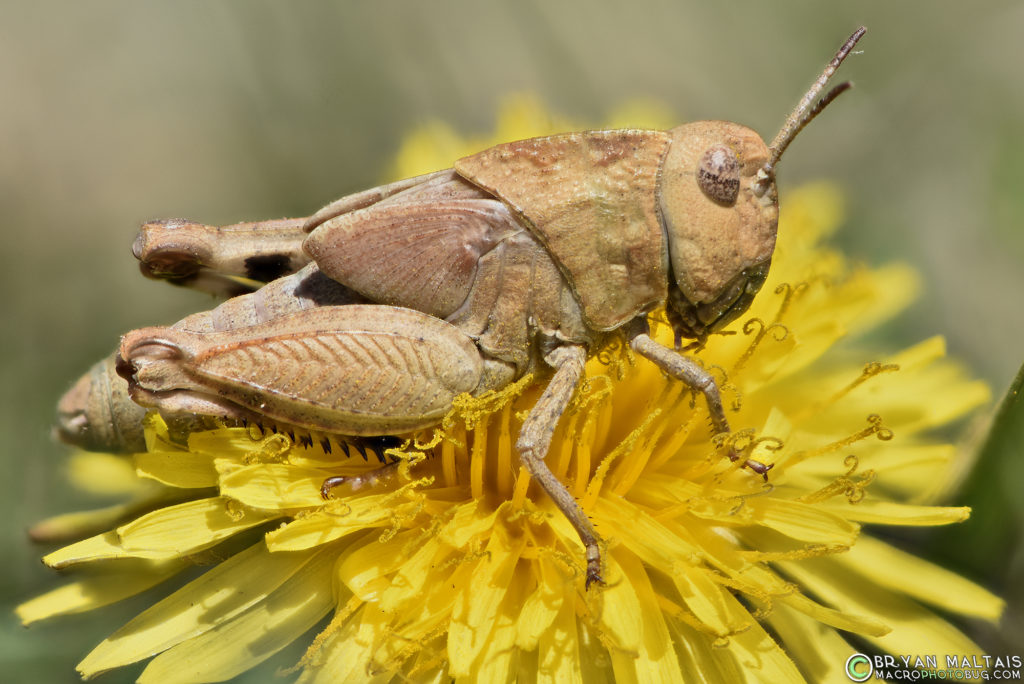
top-left (658, 28), bottom-right (864, 340)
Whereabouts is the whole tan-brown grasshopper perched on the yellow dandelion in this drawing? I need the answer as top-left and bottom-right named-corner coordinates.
top-left (59, 28), bottom-right (864, 586)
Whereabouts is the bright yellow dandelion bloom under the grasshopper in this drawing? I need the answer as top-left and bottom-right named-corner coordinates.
top-left (19, 98), bottom-right (1002, 683)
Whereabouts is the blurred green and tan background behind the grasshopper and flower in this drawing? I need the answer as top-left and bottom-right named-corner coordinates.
top-left (0, 0), bottom-right (1024, 682)
